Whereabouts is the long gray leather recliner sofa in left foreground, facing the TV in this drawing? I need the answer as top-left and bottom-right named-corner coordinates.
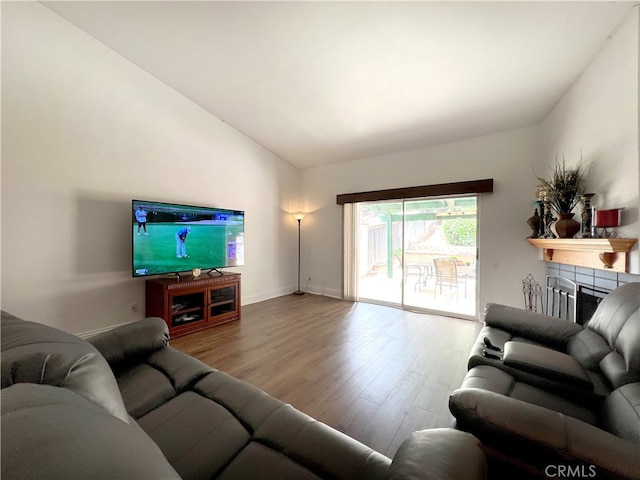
top-left (1, 312), bottom-right (486, 480)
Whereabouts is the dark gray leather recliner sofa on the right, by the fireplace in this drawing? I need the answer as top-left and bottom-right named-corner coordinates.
top-left (449, 283), bottom-right (640, 479)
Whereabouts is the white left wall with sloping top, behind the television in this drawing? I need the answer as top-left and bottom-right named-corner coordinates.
top-left (2, 2), bottom-right (299, 333)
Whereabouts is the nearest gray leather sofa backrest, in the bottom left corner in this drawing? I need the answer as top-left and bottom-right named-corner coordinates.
top-left (0, 383), bottom-right (180, 480)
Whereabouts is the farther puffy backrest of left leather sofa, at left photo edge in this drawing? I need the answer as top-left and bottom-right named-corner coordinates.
top-left (1, 312), bottom-right (129, 422)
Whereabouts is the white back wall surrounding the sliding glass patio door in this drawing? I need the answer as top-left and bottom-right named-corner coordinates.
top-left (301, 127), bottom-right (545, 314)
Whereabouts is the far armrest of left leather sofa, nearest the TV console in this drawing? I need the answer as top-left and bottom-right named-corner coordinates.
top-left (87, 317), bottom-right (169, 367)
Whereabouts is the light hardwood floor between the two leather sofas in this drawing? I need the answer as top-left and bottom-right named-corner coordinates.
top-left (171, 294), bottom-right (481, 457)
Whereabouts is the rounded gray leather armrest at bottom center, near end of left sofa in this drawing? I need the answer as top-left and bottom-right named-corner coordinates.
top-left (387, 428), bottom-right (487, 480)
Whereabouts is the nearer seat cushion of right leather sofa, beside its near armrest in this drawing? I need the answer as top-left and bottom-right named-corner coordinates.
top-left (460, 365), bottom-right (599, 425)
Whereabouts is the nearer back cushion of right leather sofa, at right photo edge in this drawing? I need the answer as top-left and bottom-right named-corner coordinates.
top-left (603, 383), bottom-right (640, 445)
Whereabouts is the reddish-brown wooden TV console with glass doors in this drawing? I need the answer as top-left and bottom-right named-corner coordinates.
top-left (145, 273), bottom-right (240, 337)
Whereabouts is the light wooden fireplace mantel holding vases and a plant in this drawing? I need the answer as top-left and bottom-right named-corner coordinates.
top-left (527, 238), bottom-right (637, 273)
